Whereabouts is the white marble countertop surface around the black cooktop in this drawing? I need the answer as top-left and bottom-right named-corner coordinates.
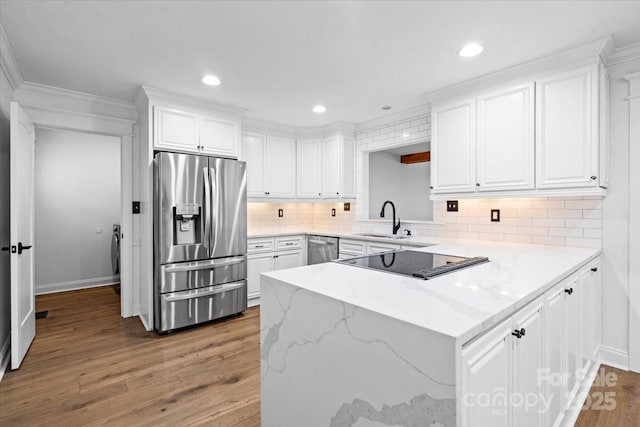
top-left (266, 239), bottom-right (601, 344)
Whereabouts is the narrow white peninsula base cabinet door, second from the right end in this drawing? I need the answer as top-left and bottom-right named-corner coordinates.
top-left (564, 279), bottom-right (582, 406)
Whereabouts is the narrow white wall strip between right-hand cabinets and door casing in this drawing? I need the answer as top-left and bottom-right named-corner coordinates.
top-left (602, 59), bottom-right (640, 365)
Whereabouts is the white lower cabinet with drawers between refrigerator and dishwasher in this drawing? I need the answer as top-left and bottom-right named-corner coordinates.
top-left (247, 235), bottom-right (306, 306)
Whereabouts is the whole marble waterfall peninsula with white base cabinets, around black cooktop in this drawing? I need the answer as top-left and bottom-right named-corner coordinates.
top-left (260, 239), bottom-right (600, 427)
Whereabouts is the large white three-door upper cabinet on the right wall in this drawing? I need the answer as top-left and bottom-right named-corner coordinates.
top-left (431, 63), bottom-right (609, 198)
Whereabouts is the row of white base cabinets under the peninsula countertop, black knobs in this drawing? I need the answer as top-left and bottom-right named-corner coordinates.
top-left (460, 259), bottom-right (601, 427)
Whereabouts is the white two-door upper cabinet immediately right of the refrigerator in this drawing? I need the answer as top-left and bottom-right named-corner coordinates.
top-left (240, 132), bottom-right (296, 199)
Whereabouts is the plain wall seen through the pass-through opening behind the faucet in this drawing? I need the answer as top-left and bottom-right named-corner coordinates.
top-left (369, 151), bottom-right (433, 221)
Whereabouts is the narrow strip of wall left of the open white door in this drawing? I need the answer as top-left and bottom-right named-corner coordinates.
top-left (0, 58), bottom-right (13, 356)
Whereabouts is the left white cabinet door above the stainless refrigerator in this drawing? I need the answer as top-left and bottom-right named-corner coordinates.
top-left (153, 107), bottom-right (200, 153)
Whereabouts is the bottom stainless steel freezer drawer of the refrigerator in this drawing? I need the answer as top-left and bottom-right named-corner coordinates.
top-left (156, 280), bottom-right (247, 332)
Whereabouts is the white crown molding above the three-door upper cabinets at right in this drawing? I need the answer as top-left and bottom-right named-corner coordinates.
top-left (424, 36), bottom-right (615, 102)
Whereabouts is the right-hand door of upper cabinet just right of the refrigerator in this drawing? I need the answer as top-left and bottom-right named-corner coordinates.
top-left (264, 136), bottom-right (296, 198)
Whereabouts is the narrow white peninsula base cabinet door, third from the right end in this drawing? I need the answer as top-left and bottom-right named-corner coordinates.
top-left (542, 284), bottom-right (565, 427)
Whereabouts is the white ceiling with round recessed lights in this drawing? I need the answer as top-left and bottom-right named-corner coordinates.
top-left (0, 0), bottom-right (640, 126)
